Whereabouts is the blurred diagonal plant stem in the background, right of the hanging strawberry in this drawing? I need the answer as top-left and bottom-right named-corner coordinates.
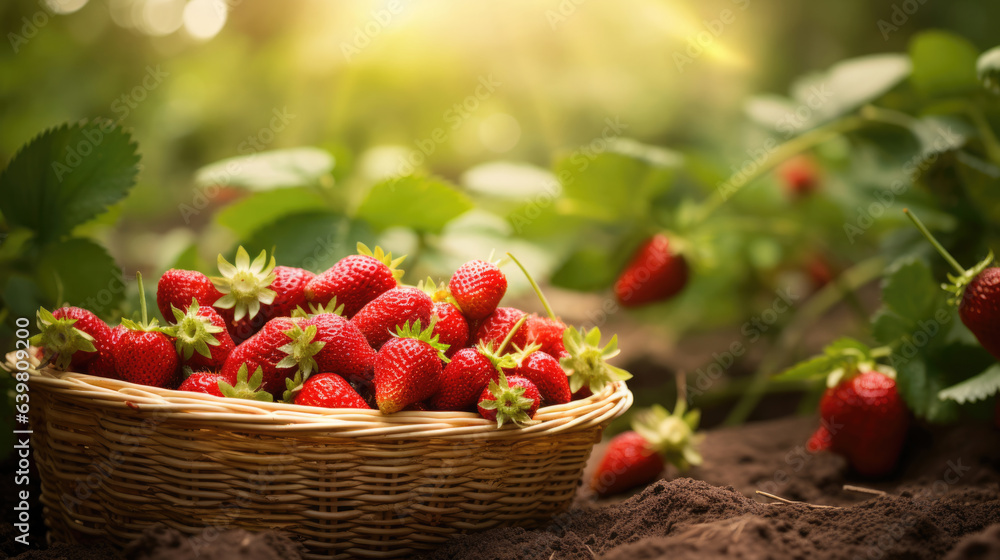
top-left (725, 257), bottom-right (885, 425)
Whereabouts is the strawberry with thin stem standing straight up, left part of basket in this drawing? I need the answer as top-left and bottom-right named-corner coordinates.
top-left (112, 272), bottom-right (180, 389)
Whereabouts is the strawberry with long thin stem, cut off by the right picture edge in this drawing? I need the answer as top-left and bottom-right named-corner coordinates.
top-left (903, 209), bottom-right (1000, 360)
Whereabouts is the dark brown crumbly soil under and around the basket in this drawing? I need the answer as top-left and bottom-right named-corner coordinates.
top-left (7, 418), bottom-right (1000, 560)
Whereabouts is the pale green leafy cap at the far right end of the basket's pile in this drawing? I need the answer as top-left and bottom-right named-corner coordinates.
top-left (559, 327), bottom-right (632, 394)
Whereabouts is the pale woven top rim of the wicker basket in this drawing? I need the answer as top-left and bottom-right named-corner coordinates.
top-left (0, 352), bottom-right (633, 440)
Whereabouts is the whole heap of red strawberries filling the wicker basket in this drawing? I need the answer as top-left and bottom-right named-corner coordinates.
top-left (33, 243), bottom-right (631, 426)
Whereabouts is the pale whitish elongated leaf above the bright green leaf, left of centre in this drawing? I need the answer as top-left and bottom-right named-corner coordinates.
top-left (195, 148), bottom-right (335, 191)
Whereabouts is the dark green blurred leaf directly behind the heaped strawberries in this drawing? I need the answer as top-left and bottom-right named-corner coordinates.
top-left (242, 212), bottom-right (375, 272)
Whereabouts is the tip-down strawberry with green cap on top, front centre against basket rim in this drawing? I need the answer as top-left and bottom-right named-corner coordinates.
top-left (372, 322), bottom-right (447, 414)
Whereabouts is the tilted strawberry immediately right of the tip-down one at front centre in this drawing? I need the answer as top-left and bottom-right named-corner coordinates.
top-left (428, 346), bottom-right (516, 410)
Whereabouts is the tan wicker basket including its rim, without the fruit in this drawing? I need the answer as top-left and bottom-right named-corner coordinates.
top-left (7, 356), bottom-right (632, 558)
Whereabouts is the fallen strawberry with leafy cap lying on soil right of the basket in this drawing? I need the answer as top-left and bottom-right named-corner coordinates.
top-left (590, 397), bottom-right (703, 496)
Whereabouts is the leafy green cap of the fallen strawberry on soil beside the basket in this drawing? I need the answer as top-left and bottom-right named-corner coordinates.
top-left (632, 398), bottom-right (705, 471)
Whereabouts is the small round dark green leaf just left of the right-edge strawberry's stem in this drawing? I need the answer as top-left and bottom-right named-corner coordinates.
top-left (882, 257), bottom-right (944, 321)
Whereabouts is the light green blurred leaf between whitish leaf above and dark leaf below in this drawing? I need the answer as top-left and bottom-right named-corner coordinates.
top-left (215, 188), bottom-right (326, 238)
